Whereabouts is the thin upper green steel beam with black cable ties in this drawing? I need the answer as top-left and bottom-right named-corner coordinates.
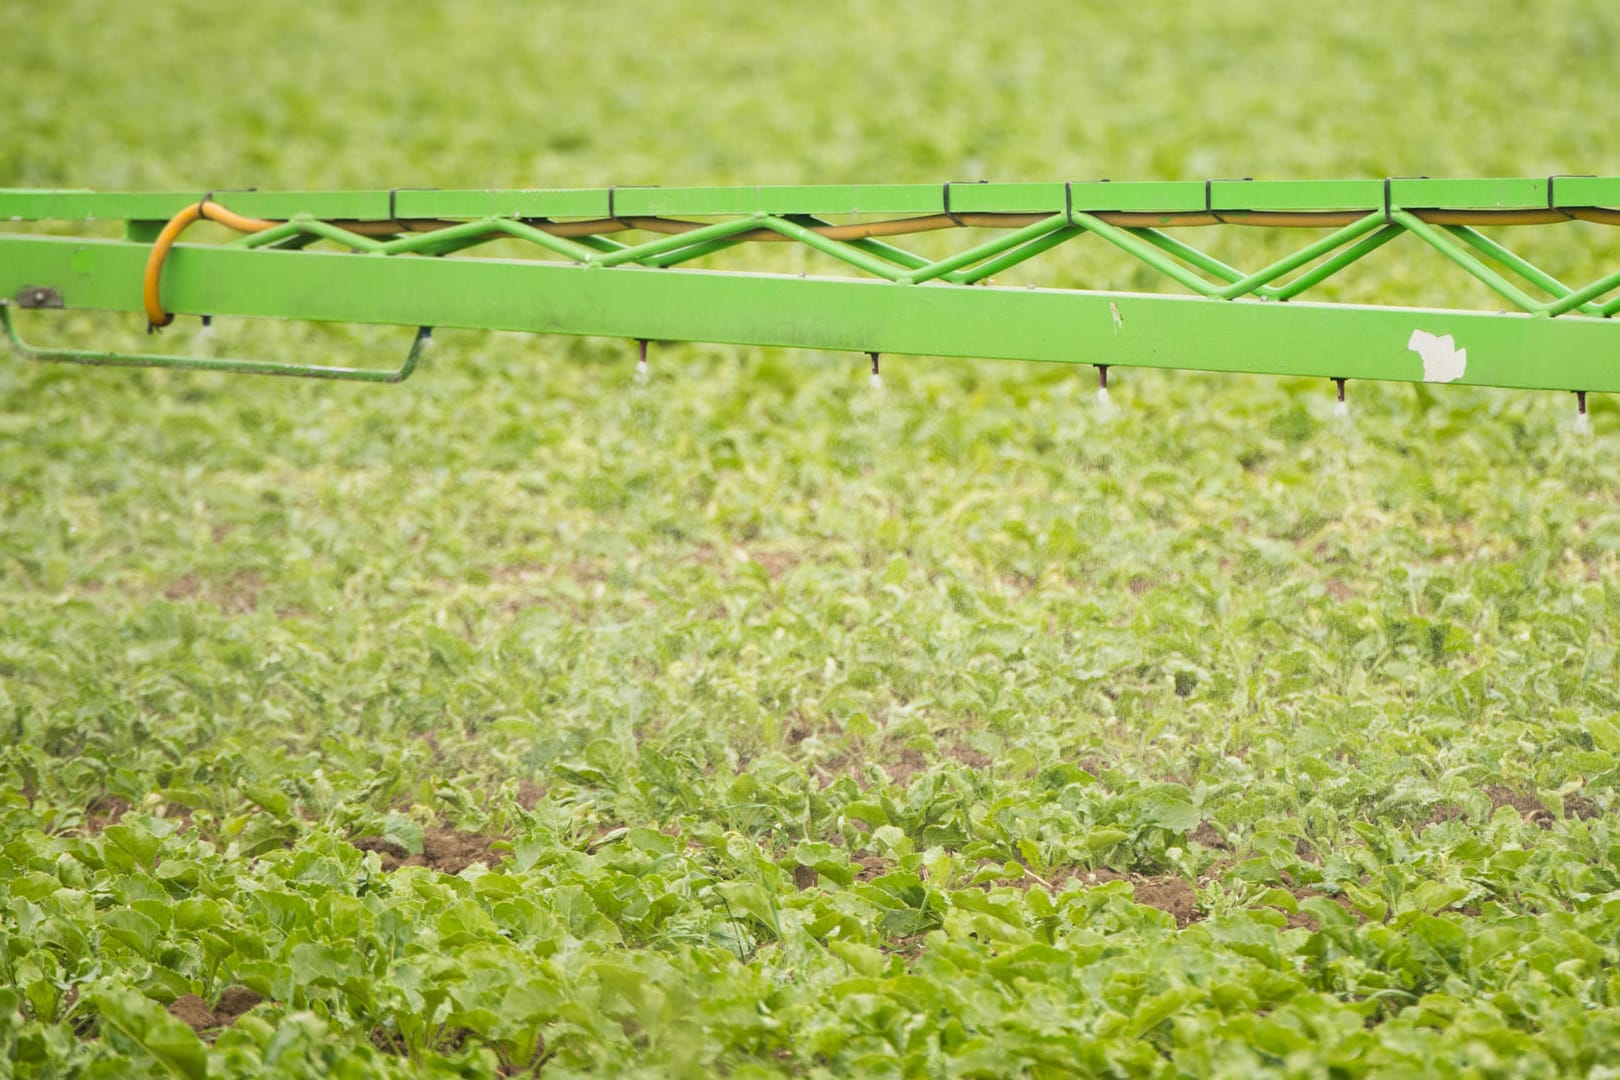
top-left (9, 176), bottom-right (1620, 222)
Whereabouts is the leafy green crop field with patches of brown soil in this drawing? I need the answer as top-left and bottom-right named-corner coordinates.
top-left (0, 0), bottom-right (1620, 1077)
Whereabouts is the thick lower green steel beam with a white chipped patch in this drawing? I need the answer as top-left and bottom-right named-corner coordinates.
top-left (0, 236), bottom-right (1620, 392)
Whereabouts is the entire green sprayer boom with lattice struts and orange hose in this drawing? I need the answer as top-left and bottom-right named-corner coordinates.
top-left (0, 176), bottom-right (1620, 406)
